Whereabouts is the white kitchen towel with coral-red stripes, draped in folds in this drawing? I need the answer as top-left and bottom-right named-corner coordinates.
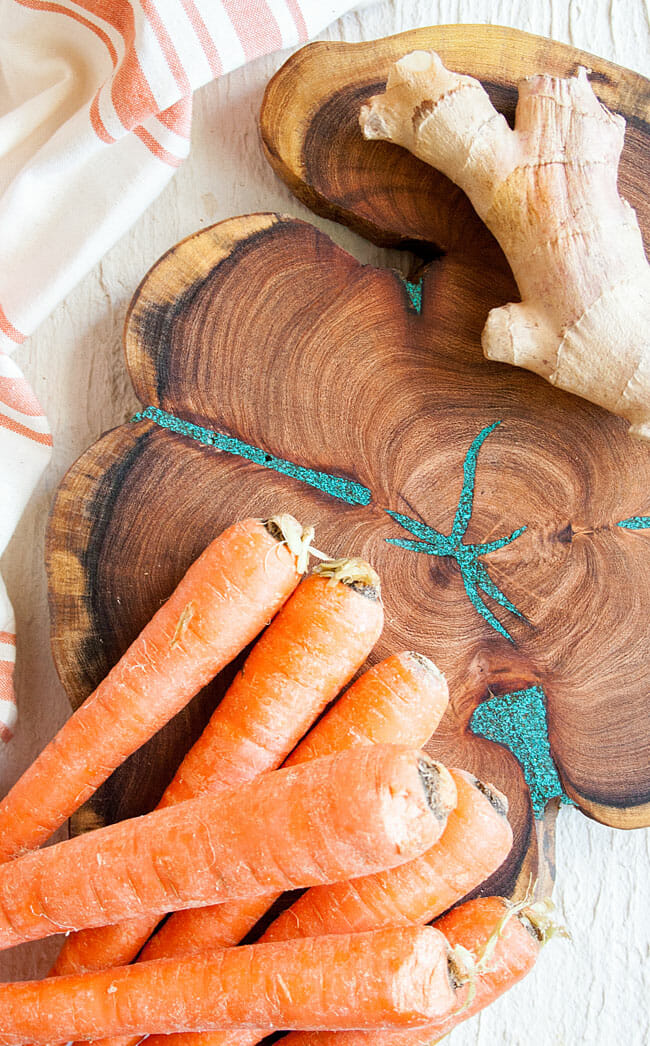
top-left (0, 0), bottom-right (360, 741)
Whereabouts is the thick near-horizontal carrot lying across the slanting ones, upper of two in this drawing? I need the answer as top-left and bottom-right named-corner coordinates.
top-left (0, 745), bottom-right (456, 948)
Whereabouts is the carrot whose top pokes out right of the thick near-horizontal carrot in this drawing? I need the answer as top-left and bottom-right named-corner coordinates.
top-left (148, 770), bottom-right (512, 1046)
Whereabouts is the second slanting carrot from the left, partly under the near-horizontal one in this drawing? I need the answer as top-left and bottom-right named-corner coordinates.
top-left (52, 561), bottom-right (385, 974)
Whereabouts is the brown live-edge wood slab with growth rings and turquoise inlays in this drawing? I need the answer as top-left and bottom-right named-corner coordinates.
top-left (47, 26), bottom-right (650, 895)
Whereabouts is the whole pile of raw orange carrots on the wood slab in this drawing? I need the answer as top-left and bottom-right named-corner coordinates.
top-left (0, 516), bottom-right (551, 1046)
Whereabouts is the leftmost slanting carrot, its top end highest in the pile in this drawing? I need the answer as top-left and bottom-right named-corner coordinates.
top-left (0, 516), bottom-right (313, 861)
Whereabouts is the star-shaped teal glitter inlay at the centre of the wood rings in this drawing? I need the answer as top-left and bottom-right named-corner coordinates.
top-left (386, 422), bottom-right (525, 642)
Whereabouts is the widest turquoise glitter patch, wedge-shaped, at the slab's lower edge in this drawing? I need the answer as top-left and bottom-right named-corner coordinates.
top-left (470, 686), bottom-right (575, 817)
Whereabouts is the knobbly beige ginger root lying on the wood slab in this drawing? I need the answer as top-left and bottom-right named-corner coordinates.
top-left (360, 51), bottom-right (650, 439)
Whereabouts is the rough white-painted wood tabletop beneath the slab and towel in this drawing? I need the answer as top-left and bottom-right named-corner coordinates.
top-left (0, 0), bottom-right (650, 1046)
